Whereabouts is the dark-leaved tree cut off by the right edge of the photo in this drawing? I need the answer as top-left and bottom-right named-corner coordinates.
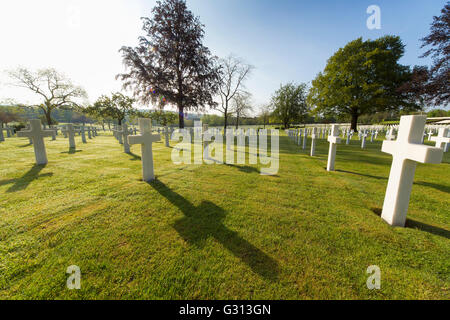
top-left (416, 2), bottom-right (450, 106)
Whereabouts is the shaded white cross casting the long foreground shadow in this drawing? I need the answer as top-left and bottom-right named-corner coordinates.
top-left (128, 119), bottom-right (161, 182)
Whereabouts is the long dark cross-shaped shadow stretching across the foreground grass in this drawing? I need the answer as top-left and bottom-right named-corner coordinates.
top-left (149, 180), bottom-right (279, 281)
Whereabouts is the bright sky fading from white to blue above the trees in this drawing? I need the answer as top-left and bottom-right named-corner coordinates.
top-left (0, 0), bottom-right (446, 114)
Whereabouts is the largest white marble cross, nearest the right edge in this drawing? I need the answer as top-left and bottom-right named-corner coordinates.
top-left (381, 116), bottom-right (443, 227)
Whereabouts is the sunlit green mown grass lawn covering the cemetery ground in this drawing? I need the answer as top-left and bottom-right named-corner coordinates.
top-left (0, 133), bottom-right (450, 299)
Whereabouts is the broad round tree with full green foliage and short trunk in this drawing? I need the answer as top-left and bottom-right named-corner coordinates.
top-left (308, 36), bottom-right (422, 131)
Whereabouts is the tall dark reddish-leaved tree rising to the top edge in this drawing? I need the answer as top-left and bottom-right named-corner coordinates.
top-left (117, 0), bottom-right (219, 128)
